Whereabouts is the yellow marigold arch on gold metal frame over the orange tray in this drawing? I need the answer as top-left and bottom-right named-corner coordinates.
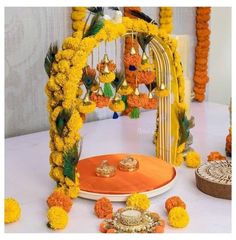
top-left (45, 17), bottom-right (184, 198)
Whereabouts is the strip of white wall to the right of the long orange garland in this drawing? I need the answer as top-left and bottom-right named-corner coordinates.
top-left (207, 7), bottom-right (231, 104)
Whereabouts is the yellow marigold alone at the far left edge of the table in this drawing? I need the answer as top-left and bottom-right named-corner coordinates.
top-left (4, 198), bottom-right (21, 223)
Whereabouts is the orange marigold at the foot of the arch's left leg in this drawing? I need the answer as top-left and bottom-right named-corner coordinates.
top-left (47, 191), bottom-right (73, 212)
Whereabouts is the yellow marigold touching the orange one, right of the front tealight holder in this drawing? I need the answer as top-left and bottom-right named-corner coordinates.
top-left (168, 207), bottom-right (189, 228)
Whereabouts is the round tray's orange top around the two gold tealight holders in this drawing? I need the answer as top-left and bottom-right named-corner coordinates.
top-left (77, 154), bottom-right (176, 194)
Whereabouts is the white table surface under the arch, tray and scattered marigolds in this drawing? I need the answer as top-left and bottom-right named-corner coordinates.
top-left (5, 103), bottom-right (231, 233)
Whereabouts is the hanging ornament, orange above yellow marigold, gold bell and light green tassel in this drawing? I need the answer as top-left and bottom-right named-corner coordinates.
top-left (97, 43), bottom-right (116, 97)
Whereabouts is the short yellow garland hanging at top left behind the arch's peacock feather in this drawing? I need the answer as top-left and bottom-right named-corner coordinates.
top-left (71, 7), bottom-right (86, 31)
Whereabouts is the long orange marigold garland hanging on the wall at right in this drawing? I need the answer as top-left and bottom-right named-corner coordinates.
top-left (193, 7), bottom-right (211, 102)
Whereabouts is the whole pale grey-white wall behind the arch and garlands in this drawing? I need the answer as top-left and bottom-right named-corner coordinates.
top-left (5, 7), bottom-right (231, 137)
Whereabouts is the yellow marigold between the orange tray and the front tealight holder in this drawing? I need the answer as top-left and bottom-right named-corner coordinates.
top-left (126, 193), bottom-right (150, 210)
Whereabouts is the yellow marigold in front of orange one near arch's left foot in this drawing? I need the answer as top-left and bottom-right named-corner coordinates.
top-left (48, 207), bottom-right (68, 230)
